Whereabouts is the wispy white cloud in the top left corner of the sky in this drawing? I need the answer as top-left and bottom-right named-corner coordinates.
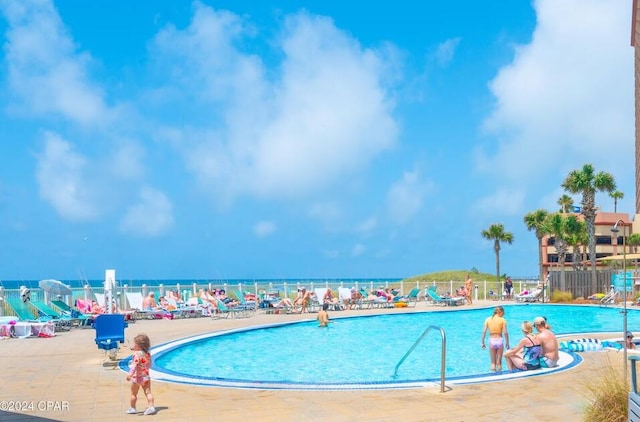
top-left (0, 1), bottom-right (108, 124)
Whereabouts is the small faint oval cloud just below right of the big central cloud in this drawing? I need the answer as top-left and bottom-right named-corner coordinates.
top-left (387, 170), bottom-right (432, 224)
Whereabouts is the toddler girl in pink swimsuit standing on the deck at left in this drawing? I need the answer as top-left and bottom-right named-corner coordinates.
top-left (127, 334), bottom-right (156, 415)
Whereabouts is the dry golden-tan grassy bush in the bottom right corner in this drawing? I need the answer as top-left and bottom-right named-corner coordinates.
top-left (584, 361), bottom-right (629, 422)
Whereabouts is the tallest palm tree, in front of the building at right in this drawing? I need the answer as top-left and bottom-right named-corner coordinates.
top-left (562, 164), bottom-right (616, 292)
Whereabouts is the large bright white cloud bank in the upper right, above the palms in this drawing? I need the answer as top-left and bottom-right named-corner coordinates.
top-left (477, 0), bottom-right (634, 184)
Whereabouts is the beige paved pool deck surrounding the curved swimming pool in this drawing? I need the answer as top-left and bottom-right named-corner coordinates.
top-left (0, 301), bottom-right (623, 422)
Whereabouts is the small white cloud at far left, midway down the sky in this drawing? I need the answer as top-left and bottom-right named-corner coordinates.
top-left (36, 132), bottom-right (100, 221)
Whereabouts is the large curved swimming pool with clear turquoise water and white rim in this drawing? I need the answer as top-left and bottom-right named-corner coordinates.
top-left (132, 304), bottom-right (640, 389)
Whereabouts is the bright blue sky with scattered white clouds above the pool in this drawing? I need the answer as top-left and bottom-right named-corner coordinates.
top-left (0, 0), bottom-right (634, 280)
